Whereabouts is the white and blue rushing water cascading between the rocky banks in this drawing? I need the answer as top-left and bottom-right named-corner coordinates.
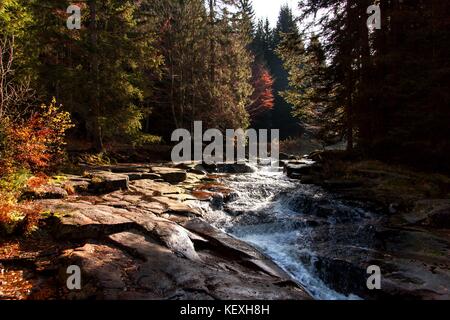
top-left (198, 162), bottom-right (380, 300)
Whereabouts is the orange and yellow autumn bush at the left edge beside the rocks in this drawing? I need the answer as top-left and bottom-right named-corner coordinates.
top-left (0, 99), bottom-right (72, 235)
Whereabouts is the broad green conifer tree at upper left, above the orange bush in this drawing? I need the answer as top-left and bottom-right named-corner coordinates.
top-left (28, 0), bottom-right (162, 151)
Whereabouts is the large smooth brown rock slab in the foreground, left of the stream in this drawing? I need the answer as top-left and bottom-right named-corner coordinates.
top-left (61, 230), bottom-right (309, 300)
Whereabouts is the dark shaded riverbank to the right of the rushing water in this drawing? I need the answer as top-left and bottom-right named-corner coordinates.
top-left (285, 152), bottom-right (450, 299)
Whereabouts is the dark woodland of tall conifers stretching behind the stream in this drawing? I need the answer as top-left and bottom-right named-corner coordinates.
top-left (0, 0), bottom-right (450, 170)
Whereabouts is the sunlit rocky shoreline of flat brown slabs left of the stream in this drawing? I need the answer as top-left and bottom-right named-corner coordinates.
top-left (9, 164), bottom-right (311, 300)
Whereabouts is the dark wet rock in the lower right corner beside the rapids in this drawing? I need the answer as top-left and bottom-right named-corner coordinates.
top-left (299, 221), bottom-right (450, 300)
